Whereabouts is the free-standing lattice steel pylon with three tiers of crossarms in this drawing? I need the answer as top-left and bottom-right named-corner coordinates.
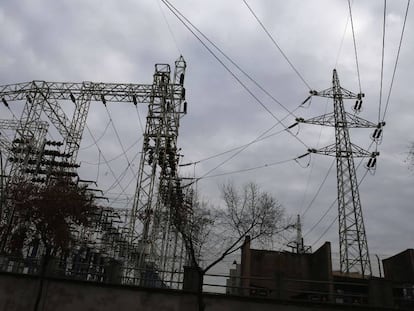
top-left (296, 69), bottom-right (385, 276)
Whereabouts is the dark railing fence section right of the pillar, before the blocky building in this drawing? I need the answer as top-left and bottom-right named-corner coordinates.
top-left (203, 274), bottom-right (414, 310)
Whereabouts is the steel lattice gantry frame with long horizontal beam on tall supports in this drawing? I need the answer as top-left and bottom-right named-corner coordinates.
top-left (0, 56), bottom-right (187, 288)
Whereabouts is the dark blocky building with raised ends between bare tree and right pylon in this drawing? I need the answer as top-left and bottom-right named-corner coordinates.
top-left (241, 238), bottom-right (332, 301)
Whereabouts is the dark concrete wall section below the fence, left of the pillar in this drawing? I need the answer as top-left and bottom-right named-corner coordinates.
top-left (0, 274), bottom-right (196, 311)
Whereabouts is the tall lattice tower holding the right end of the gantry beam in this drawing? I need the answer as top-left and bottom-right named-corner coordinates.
top-left (131, 57), bottom-right (187, 276)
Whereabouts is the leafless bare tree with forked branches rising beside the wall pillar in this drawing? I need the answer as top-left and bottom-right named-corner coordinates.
top-left (173, 183), bottom-right (289, 310)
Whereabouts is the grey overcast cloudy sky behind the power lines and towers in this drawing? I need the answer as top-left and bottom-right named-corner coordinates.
top-left (0, 0), bottom-right (414, 268)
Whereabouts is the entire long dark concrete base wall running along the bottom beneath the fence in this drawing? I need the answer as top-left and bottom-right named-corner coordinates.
top-left (0, 273), bottom-right (396, 311)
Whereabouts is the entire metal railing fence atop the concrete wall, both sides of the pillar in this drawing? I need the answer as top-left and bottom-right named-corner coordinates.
top-left (0, 257), bottom-right (414, 310)
